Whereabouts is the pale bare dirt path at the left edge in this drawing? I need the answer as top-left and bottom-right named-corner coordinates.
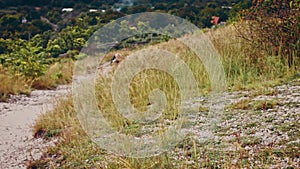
top-left (0, 85), bottom-right (71, 169)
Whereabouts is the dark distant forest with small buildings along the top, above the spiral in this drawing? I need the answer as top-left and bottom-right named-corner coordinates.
top-left (0, 0), bottom-right (251, 39)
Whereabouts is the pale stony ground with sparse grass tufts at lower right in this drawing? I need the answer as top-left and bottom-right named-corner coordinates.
top-left (173, 79), bottom-right (300, 168)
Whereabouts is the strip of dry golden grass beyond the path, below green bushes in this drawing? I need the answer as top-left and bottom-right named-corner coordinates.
top-left (0, 60), bottom-right (74, 101)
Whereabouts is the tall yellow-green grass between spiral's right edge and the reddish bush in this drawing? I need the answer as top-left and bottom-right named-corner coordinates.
top-left (208, 25), bottom-right (299, 90)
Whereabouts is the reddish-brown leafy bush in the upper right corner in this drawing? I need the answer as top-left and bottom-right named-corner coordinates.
top-left (240, 0), bottom-right (300, 66)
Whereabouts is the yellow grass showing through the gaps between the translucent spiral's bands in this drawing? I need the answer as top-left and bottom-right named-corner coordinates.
top-left (96, 40), bottom-right (210, 132)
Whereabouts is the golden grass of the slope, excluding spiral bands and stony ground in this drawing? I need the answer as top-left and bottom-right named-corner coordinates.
top-left (31, 26), bottom-right (299, 168)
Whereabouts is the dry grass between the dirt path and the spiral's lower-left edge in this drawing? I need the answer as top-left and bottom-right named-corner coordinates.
top-left (28, 97), bottom-right (192, 169)
